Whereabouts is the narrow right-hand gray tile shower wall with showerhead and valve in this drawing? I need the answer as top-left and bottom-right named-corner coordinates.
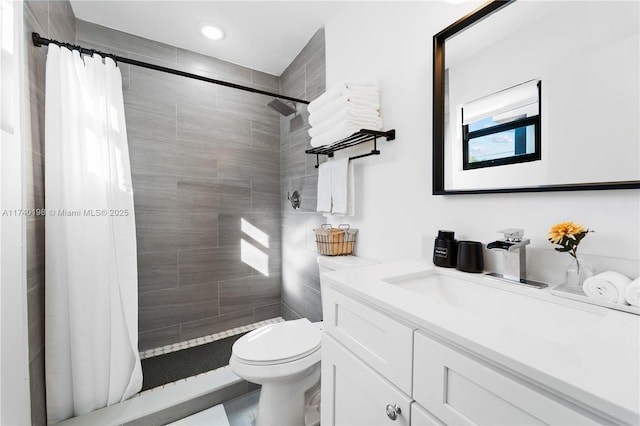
top-left (280, 29), bottom-right (326, 321)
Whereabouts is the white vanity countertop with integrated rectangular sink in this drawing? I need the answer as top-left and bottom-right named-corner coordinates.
top-left (321, 260), bottom-right (640, 424)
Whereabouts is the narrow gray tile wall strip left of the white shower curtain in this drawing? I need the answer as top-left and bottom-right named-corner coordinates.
top-left (23, 0), bottom-right (76, 425)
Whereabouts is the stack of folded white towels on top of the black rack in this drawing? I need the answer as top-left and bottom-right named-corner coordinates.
top-left (307, 81), bottom-right (382, 147)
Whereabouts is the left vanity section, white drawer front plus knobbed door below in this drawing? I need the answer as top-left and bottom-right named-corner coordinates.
top-left (321, 288), bottom-right (441, 426)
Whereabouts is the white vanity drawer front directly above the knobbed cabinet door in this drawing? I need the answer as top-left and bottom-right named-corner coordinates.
top-left (322, 286), bottom-right (414, 395)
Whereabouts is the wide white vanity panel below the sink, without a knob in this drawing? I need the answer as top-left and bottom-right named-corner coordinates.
top-left (413, 333), bottom-right (602, 426)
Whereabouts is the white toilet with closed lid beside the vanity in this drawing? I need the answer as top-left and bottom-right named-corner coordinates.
top-left (229, 256), bottom-right (374, 426)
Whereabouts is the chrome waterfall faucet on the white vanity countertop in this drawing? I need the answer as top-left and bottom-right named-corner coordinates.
top-left (487, 228), bottom-right (547, 288)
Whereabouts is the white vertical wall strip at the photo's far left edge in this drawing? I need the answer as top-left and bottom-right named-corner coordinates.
top-left (0, 0), bottom-right (31, 425)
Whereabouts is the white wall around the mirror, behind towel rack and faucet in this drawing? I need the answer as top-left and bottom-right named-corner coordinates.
top-left (325, 2), bottom-right (640, 281)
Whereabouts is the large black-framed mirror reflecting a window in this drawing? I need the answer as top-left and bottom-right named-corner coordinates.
top-left (433, 0), bottom-right (640, 195)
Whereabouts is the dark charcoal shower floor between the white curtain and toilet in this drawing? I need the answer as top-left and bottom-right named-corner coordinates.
top-left (142, 333), bottom-right (246, 391)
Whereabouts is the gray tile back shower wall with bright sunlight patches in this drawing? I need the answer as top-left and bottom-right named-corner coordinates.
top-left (77, 20), bottom-right (281, 350)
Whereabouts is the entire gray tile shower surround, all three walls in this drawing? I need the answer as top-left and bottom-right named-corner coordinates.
top-left (24, 7), bottom-right (325, 425)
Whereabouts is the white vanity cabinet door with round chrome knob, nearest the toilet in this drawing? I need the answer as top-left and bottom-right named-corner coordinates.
top-left (321, 334), bottom-right (411, 426)
